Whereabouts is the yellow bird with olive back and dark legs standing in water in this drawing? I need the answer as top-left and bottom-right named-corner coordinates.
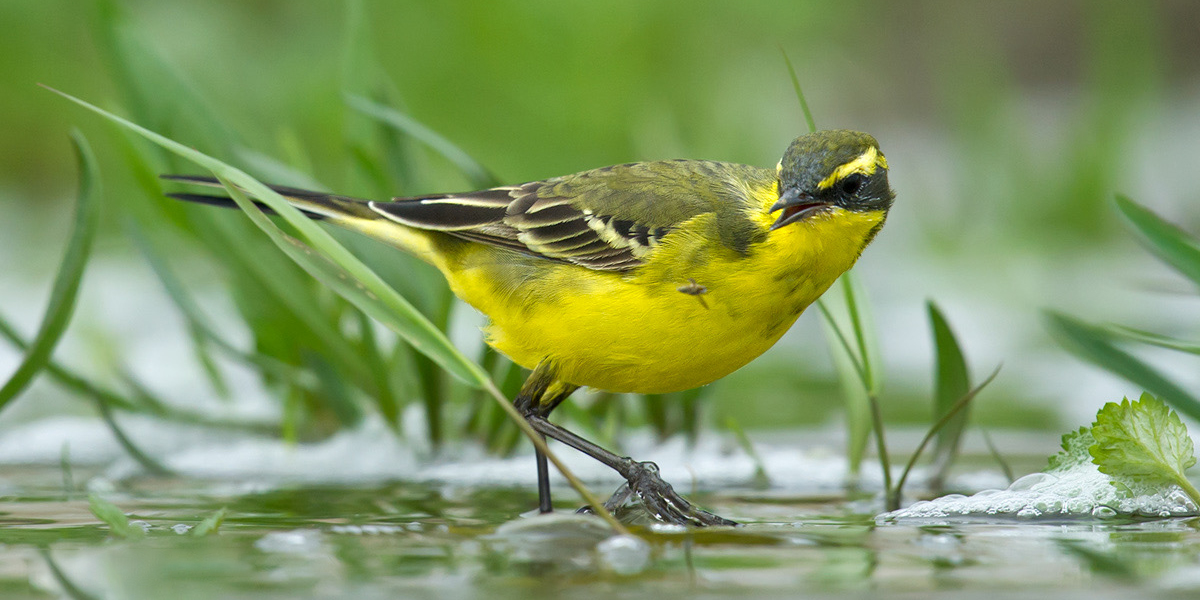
top-left (163, 130), bottom-right (895, 527)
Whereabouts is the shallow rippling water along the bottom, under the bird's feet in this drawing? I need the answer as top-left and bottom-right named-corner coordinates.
top-left (0, 467), bottom-right (1200, 599)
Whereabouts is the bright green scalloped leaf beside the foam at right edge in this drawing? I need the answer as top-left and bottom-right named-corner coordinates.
top-left (1088, 394), bottom-right (1200, 505)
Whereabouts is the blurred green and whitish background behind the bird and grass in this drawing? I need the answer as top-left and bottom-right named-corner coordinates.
top-left (0, 0), bottom-right (1200, 446)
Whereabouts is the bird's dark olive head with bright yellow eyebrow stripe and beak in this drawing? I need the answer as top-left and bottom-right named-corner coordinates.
top-left (769, 130), bottom-right (895, 230)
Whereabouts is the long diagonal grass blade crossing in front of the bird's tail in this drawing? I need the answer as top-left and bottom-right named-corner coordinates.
top-left (47, 88), bottom-right (629, 534)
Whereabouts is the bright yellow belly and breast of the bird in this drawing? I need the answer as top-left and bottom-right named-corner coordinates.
top-left (444, 210), bottom-right (883, 394)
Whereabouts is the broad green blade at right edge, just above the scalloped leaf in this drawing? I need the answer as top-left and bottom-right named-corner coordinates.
top-left (1045, 312), bottom-right (1200, 419)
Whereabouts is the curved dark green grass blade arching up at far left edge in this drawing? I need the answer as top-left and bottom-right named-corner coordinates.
top-left (0, 132), bottom-right (100, 410)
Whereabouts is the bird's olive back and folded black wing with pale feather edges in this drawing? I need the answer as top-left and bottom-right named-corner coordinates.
top-left (371, 161), bottom-right (774, 271)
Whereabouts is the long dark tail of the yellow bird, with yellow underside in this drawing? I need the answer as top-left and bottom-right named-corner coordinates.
top-left (161, 175), bottom-right (440, 266)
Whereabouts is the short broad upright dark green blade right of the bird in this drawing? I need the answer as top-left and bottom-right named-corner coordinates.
top-left (925, 300), bottom-right (971, 481)
